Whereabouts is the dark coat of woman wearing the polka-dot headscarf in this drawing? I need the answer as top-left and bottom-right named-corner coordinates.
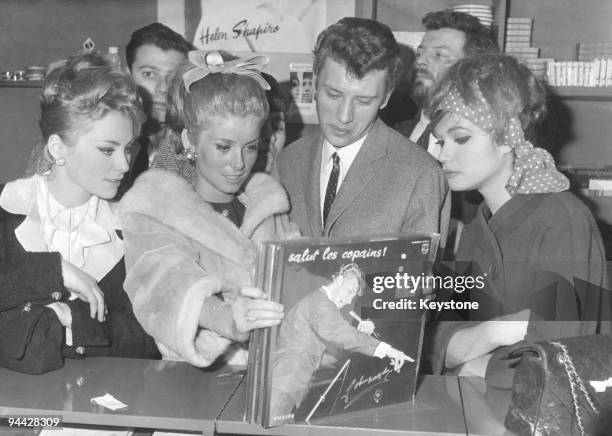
top-left (433, 192), bottom-right (612, 384)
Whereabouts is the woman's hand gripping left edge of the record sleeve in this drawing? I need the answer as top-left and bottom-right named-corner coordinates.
top-left (226, 287), bottom-right (285, 341)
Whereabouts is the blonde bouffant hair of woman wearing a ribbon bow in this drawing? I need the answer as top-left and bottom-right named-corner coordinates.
top-left (166, 53), bottom-right (269, 153)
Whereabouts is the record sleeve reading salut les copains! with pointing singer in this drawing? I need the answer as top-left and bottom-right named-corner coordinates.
top-left (247, 233), bottom-right (439, 427)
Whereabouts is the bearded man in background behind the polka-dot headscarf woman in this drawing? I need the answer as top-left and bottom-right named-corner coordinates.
top-left (395, 9), bottom-right (499, 156)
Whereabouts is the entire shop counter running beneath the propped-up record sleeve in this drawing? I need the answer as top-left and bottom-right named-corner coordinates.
top-left (0, 358), bottom-right (510, 436)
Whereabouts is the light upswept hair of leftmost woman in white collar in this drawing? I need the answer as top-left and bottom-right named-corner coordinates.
top-left (28, 53), bottom-right (145, 174)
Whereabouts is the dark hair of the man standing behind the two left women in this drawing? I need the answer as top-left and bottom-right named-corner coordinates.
top-left (125, 23), bottom-right (194, 69)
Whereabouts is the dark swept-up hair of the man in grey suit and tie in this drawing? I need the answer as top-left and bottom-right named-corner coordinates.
top-left (313, 17), bottom-right (402, 92)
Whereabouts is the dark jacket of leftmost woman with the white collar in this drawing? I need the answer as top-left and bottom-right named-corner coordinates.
top-left (0, 182), bottom-right (161, 374)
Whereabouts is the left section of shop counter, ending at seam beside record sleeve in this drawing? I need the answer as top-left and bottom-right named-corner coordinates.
top-left (0, 357), bottom-right (244, 435)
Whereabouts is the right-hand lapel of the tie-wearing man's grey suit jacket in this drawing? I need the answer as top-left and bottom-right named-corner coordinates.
top-left (326, 120), bottom-right (387, 234)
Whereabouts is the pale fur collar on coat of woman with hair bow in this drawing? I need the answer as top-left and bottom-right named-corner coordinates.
top-left (119, 169), bottom-right (289, 264)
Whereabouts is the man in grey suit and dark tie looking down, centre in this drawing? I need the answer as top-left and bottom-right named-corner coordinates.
top-left (276, 17), bottom-right (448, 237)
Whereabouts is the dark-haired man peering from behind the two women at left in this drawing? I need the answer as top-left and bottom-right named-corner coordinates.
top-left (122, 23), bottom-right (193, 192)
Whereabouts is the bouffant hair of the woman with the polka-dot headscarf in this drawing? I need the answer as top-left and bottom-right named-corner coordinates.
top-left (431, 54), bottom-right (546, 143)
